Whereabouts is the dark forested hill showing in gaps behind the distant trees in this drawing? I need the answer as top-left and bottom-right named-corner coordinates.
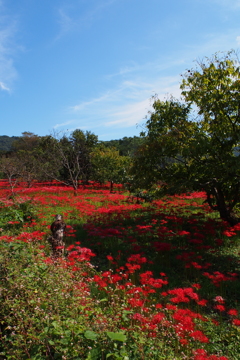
top-left (0, 135), bottom-right (143, 156)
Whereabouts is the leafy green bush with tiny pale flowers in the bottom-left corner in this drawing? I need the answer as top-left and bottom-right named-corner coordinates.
top-left (0, 240), bottom-right (178, 360)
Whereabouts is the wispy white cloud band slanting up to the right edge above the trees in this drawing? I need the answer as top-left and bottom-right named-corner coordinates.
top-left (63, 29), bottom-right (240, 136)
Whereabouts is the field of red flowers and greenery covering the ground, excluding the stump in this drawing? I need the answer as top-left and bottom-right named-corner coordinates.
top-left (0, 182), bottom-right (240, 360)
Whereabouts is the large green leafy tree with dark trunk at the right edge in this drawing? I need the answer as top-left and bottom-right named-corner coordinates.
top-left (134, 52), bottom-right (240, 225)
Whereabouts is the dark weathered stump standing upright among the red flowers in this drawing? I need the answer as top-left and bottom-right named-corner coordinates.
top-left (49, 215), bottom-right (66, 258)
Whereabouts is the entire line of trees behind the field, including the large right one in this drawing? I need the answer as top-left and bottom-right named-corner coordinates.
top-left (1, 51), bottom-right (240, 225)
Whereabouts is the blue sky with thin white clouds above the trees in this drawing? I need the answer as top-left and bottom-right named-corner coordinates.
top-left (0, 0), bottom-right (240, 140)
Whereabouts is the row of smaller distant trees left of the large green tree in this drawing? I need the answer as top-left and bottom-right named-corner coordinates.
top-left (0, 129), bottom-right (130, 191)
